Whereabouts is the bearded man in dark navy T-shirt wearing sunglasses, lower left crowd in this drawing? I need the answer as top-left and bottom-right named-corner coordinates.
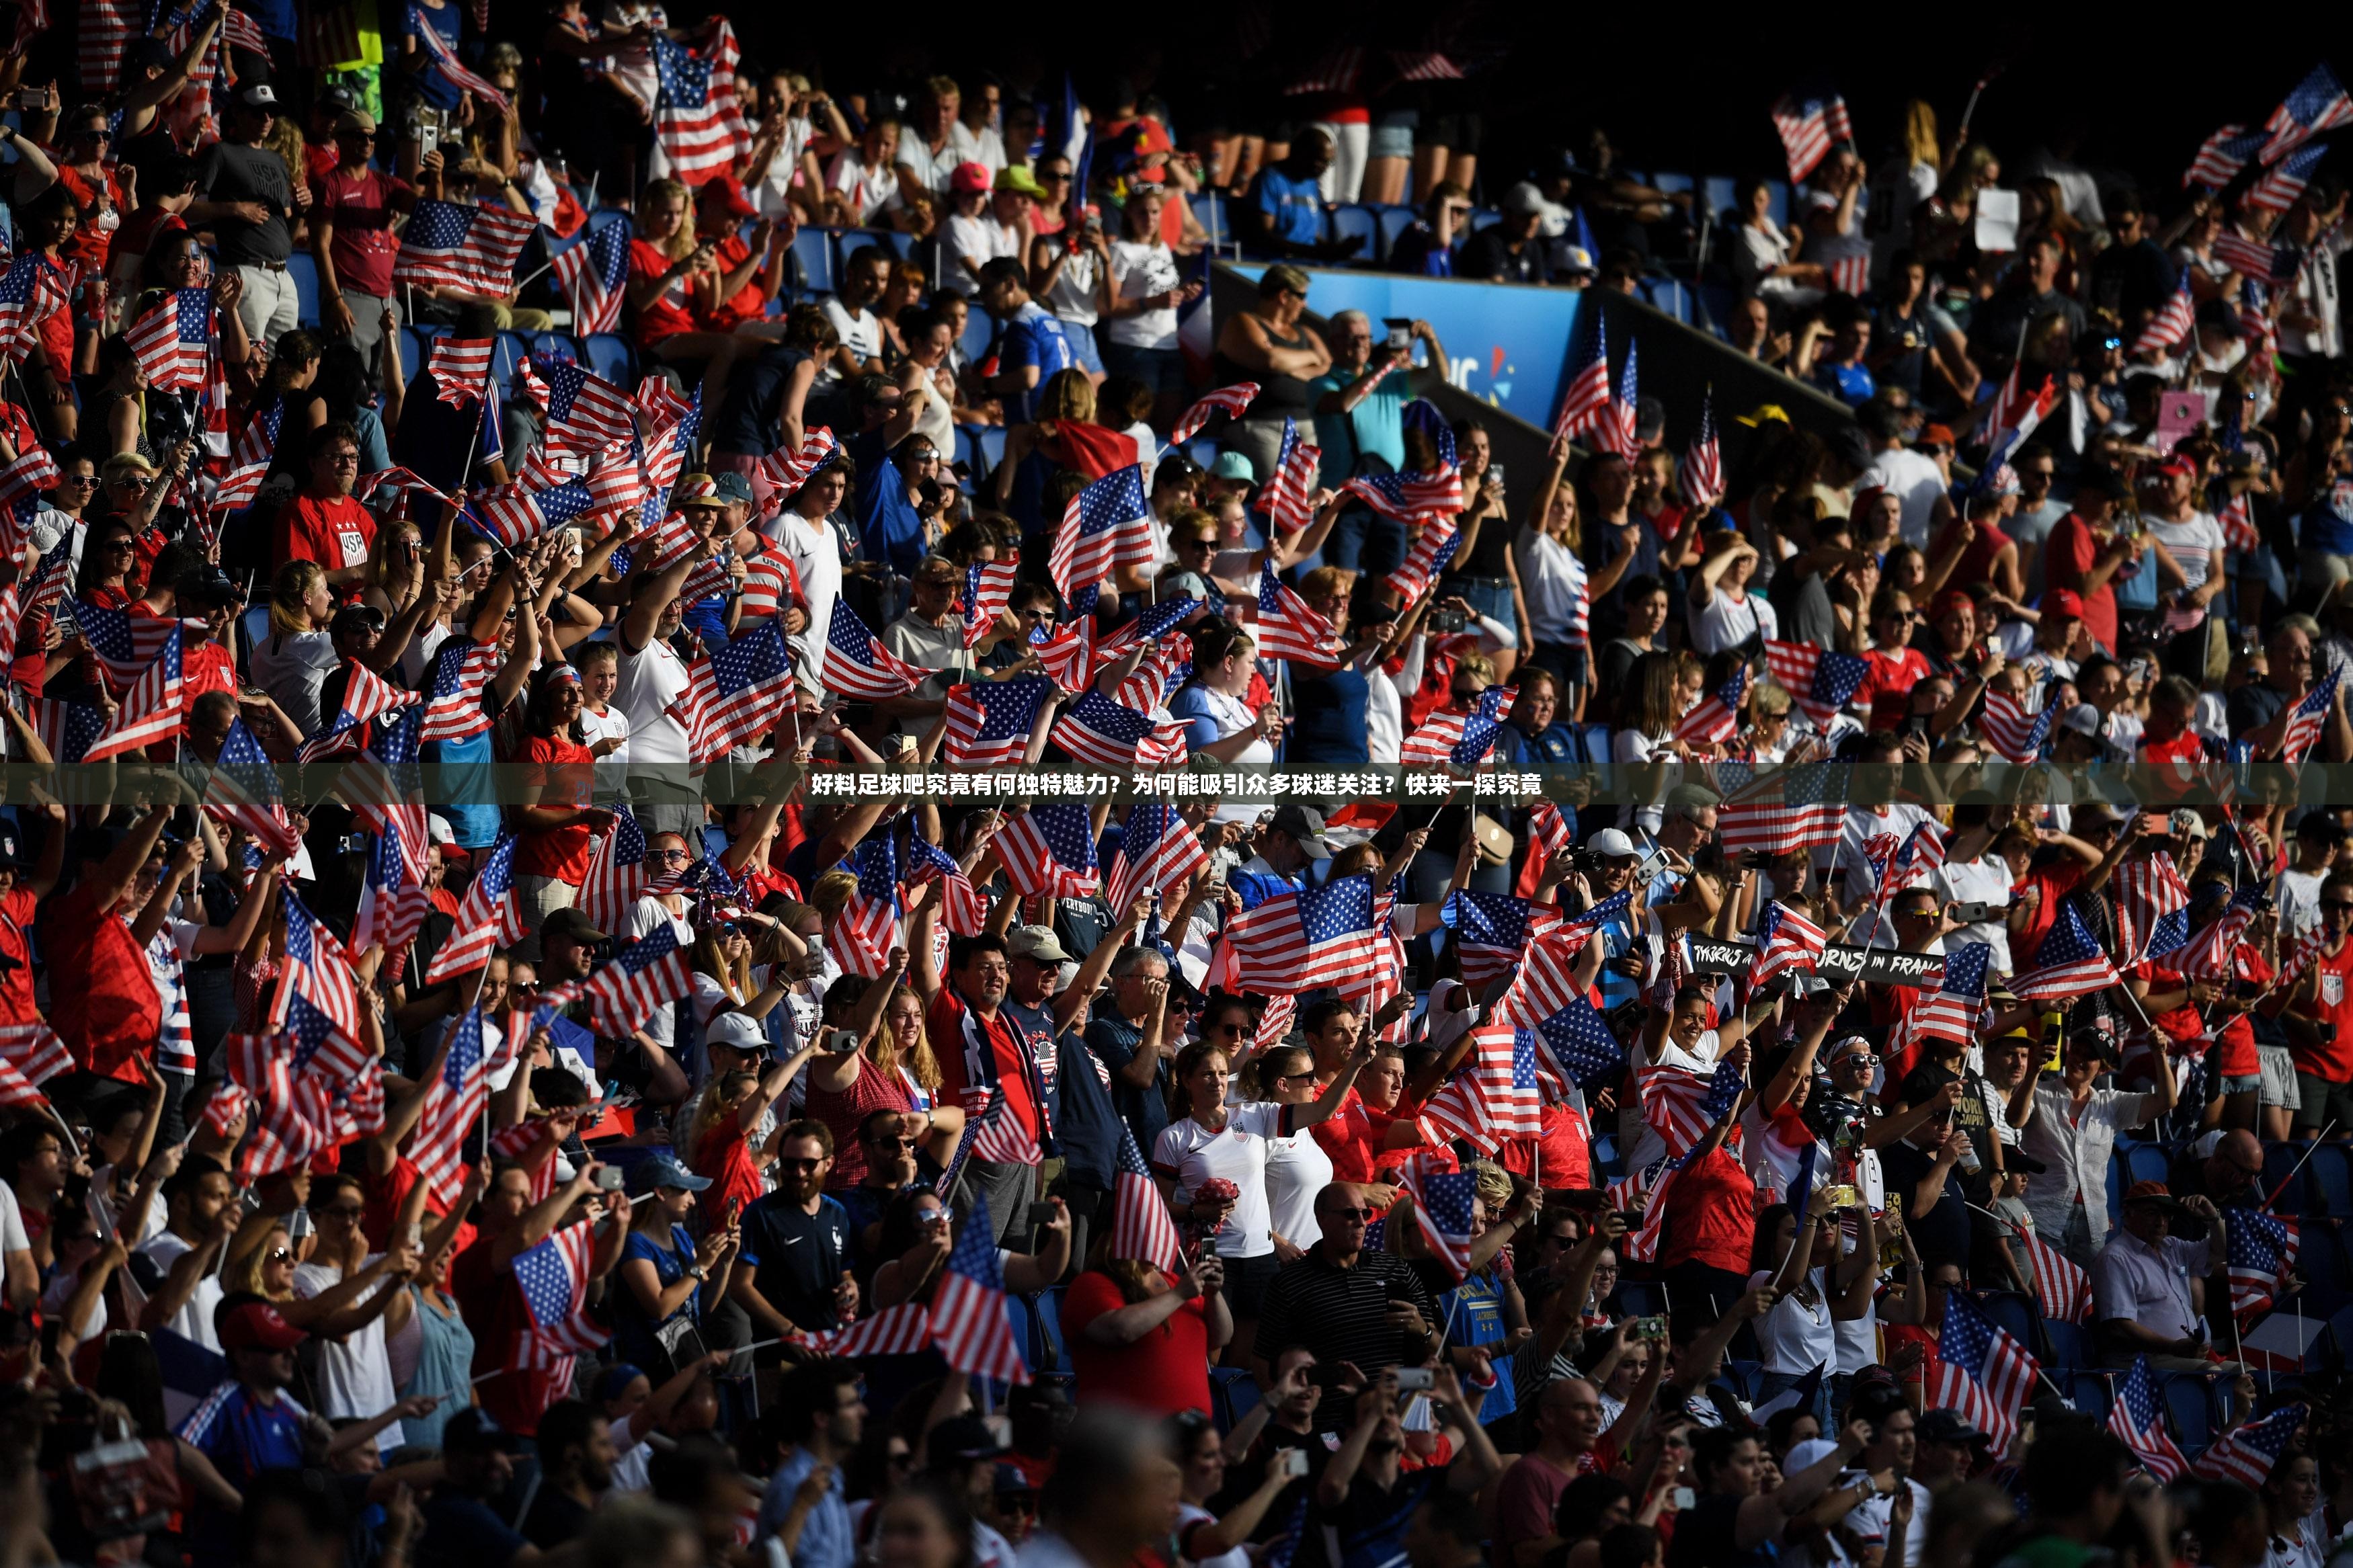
top-left (727, 1121), bottom-right (859, 1340)
